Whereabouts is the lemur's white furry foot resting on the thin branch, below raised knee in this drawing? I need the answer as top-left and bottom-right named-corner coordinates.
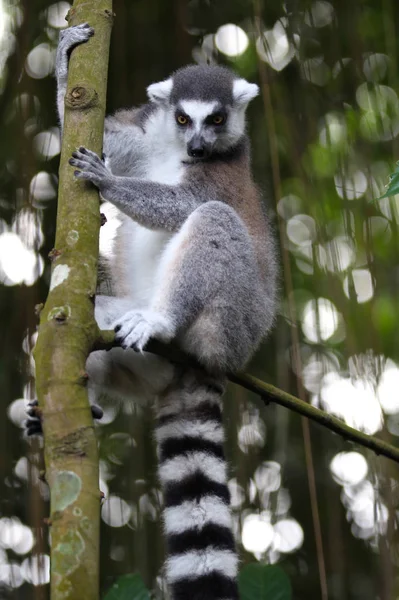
top-left (114, 310), bottom-right (175, 352)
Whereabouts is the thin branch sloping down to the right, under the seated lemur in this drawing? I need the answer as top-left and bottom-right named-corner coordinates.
top-left (94, 331), bottom-right (399, 463)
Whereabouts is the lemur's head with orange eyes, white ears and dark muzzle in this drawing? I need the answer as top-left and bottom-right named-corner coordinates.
top-left (147, 65), bottom-right (259, 159)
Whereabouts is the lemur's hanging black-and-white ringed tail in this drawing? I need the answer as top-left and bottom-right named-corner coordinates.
top-left (156, 372), bottom-right (238, 600)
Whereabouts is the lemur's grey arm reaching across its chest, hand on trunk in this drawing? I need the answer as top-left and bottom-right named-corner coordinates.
top-left (69, 148), bottom-right (205, 232)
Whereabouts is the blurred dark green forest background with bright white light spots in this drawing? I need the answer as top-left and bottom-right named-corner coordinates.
top-left (0, 0), bottom-right (399, 600)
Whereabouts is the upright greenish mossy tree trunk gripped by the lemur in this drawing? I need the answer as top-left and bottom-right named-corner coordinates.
top-left (35, 0), bottom-right (113, 600)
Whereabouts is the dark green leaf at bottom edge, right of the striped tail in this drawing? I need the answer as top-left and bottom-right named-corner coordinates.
top-left (238, 563), bottom-right (292, 600)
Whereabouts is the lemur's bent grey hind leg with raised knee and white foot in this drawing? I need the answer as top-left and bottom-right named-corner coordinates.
top-left (114, 202), bottom-right (265, 371)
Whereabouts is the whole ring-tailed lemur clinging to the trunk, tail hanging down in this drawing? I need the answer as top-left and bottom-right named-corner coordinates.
top-left (52, 24), bottom-right (276, 600)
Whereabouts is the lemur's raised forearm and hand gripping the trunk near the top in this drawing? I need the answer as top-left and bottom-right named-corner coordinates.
top-left (55, 23), bottom-right (94, 130)
